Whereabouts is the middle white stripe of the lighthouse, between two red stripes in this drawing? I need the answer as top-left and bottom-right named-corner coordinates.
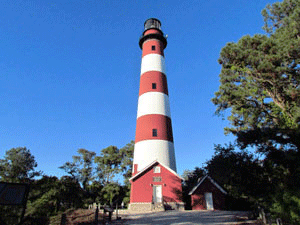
top-left (137, 92), bottom-right (171, 118)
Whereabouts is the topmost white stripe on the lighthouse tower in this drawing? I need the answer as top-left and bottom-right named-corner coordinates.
top-left (141, 54), bottom-right (166, 75)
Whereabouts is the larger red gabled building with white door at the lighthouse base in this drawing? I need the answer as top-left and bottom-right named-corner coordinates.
top-left (130, 161), bottom-right (184, 211)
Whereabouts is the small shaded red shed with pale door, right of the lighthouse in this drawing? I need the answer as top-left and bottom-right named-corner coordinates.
top-left (189, 175), bottom-right (227, 210)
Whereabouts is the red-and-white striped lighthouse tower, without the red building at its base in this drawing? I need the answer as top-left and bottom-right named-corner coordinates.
top-left (133, 18), bottom-right (176, 174)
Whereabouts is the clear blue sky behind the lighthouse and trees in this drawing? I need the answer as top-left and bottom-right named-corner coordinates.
top-left (0, 0), bottom-right (275, 179)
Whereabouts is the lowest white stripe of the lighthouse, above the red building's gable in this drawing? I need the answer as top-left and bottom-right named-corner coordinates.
top-left (133, 140), bottom-right (176, 172)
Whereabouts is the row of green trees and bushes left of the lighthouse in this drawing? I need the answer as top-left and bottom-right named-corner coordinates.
top-left (0, 142), bottom-right (134, 224)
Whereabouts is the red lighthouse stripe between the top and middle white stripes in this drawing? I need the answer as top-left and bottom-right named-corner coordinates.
top-left (139, 71), bottom-right (168, 96)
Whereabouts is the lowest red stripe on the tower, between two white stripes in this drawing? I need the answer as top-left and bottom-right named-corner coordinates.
top-left (135, 114), bottom-right (173, 143)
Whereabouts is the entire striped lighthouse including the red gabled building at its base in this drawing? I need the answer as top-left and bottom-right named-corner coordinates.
top-left (129, 18), bottom-right (183, 211)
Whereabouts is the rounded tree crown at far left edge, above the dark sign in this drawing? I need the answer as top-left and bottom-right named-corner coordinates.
top-left (0, 147), bottom-right (41, 183)
